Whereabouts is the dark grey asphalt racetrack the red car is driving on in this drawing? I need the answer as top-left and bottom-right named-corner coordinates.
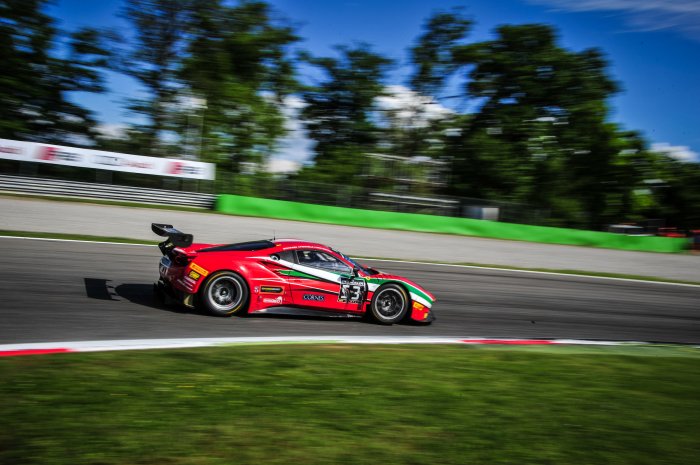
top-left (0, 238), bottom-right (700, 344)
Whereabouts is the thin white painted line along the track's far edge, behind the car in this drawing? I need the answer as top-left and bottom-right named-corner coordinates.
top-left (0, 235), bottom-right (700, 287)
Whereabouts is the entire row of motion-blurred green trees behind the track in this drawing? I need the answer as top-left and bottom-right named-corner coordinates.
top-left (0, 0), bottom-right (700, 229)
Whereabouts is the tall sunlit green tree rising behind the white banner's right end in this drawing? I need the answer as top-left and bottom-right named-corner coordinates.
top-left (179, 0), bottom-right (299, 172)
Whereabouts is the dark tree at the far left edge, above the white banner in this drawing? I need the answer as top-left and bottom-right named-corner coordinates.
top-left (0, 0), bottom-right (108, 145)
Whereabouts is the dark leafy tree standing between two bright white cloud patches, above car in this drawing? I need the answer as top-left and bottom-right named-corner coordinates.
top-left (302, 44), bottom-right (392, 184)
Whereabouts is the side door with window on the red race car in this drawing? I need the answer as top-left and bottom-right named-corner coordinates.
top-left (289, 248), bottom-right (352, 310)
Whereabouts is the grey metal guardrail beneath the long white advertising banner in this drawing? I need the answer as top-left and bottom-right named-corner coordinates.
top-left (0, 175), bottom-right (216, 208)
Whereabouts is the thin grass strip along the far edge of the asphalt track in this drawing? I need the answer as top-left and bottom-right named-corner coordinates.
top-left (0, 230), bottom-right (700, 286)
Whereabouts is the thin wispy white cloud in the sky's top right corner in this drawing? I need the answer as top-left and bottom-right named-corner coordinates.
top-left (528, 0), bottom-right (700, 40)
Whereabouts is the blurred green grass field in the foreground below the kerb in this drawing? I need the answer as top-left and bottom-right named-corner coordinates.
top-left (0, 345), bottom-right (700, 465)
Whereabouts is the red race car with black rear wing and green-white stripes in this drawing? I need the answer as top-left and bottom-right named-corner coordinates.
top-left (151, 223), bottom-right (435, 325)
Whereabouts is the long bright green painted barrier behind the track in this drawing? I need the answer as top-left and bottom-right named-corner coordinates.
top-left (215, 195), bottom-right (688, 252)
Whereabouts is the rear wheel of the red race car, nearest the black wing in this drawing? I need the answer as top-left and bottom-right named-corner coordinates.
top-left (198, 271), bottom-right (250, 316)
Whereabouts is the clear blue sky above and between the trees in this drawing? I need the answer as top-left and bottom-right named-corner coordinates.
top-left (49, 0), bottom-right (700, 159)
